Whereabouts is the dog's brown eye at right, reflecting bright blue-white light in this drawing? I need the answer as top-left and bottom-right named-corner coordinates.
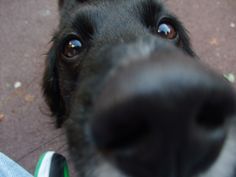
top-left (157, 22), bottom-right (177, 40)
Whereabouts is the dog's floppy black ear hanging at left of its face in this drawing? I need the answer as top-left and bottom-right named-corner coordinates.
top-left (42, 44), bottom-right (65, 127)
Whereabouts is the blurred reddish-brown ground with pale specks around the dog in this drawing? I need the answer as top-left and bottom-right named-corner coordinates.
top-left (0, 0), bottom-right (236, 176)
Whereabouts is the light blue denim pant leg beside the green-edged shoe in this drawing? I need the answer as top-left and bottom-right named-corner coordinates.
top-left (0, 152), bottom-right (33, 177)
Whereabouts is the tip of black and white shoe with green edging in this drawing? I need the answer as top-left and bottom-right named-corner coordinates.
top-left (34, 151), bottom-right (69, 177)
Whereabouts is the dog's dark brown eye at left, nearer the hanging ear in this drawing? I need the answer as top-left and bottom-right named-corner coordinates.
top-left (63, 36), bottom-right (83, 58)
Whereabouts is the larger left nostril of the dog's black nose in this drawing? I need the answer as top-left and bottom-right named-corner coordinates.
top-left (91, 100), bottom-right (148, 150)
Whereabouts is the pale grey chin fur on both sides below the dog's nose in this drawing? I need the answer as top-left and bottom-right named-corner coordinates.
top-left (85, 121), bottom-right (236, 177)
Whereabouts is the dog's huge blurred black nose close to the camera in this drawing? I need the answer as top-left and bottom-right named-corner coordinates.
top-left (91, 48), bottom-right (236, 177)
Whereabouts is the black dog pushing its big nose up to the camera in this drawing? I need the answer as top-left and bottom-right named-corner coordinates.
top-left (43, 0), bottom-right (236, 177)
